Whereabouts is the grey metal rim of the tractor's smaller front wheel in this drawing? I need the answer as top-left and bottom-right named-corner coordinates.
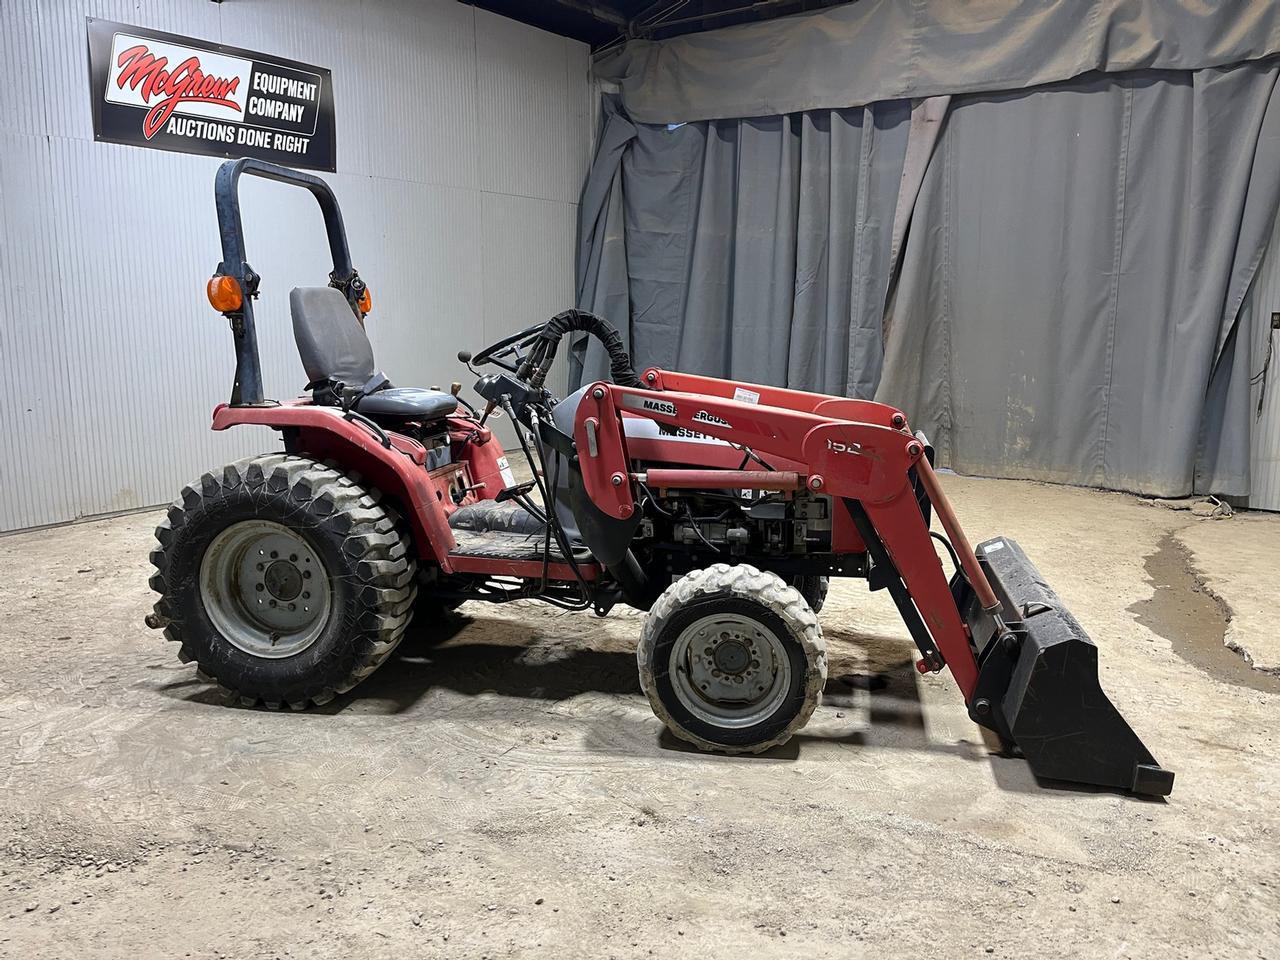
top-left (668, 613), bottom-right (791, 730)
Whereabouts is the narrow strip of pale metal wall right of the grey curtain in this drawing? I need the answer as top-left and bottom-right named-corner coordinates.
top-left (1245, 218), bottom-right (1280, 511)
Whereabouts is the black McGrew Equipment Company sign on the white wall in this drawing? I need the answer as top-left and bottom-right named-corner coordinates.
top-left (88, 17), bottom-right (337, 172)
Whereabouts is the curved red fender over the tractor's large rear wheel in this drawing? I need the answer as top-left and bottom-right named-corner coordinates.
top-left (212, 403), bottom-right (456, 573)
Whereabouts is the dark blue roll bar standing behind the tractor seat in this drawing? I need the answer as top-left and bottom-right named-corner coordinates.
top-left (214, 157), bottom-right (365, 407)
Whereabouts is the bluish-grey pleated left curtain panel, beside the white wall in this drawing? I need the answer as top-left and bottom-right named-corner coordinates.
top-left (573, 97), bottom-right (911, 397)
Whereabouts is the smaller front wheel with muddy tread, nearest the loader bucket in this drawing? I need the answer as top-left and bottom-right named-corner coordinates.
top-left (636, 563), bottom-right (827, 754)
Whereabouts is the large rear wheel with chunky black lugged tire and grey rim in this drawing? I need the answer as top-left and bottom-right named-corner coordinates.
top-left (150, 454), bottom-right (417, 709)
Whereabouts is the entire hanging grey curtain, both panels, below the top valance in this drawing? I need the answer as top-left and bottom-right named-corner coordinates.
top-left (572, 64), bottom-right (1280, 497)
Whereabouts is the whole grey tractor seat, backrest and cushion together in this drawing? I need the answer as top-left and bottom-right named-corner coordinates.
top-left (289, 287), bottom-right (458, 426)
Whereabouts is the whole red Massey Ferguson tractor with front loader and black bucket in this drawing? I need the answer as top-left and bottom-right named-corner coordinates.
top-left (148, 160), bottom-right (1174, 795)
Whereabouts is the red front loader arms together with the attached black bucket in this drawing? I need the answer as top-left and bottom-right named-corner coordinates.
top-left (573, 367), bottom-right (1174, 796)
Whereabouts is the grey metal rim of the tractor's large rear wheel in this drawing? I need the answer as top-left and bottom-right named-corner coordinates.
top-left (200, 520), bottom-right (332, 659)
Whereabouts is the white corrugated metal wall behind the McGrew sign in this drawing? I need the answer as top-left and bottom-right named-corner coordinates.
top-left (0, 0), bottom-right (590, 530)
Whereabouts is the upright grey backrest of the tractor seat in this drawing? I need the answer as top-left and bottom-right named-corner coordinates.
top-left (289, 287), bottom-right (374, 387)
